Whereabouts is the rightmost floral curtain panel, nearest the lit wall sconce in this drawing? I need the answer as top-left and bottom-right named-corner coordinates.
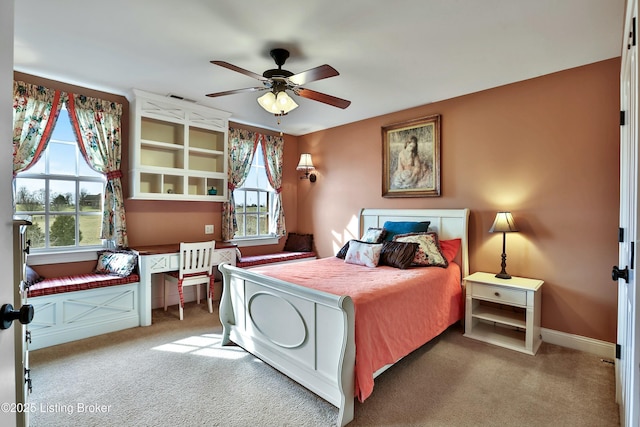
top-left (260, 135), bottom-right (287, 236)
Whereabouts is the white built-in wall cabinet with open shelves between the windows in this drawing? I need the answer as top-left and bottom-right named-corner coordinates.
top-left (129, 90), bottom-right (231, 202)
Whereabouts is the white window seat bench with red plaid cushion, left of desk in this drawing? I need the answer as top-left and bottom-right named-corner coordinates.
top-left (27, 273), bottom-right (140, 350)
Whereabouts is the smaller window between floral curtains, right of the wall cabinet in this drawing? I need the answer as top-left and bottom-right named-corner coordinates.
top-left (233, 143), bottom-right (276, 239)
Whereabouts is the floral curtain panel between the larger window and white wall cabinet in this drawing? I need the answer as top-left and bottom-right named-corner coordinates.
top-left (67, 94), bottom-right (128, 247)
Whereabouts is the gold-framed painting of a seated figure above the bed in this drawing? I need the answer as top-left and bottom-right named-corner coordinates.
top-left (382, 114), bottom-right (440, 197)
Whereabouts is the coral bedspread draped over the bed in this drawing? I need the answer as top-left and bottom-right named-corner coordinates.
top-left (248, 257), bottom-right (462, 402)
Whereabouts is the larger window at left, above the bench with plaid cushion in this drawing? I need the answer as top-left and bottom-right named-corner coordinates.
top-left (14, 107), bottom-right (105, 252)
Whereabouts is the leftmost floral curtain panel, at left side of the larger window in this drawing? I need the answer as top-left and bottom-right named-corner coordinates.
top-left (13, 81), bottom-right (64, 177)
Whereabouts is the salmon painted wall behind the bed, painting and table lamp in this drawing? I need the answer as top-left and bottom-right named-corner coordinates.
top-left (298, 58), bottom-right (620, 342)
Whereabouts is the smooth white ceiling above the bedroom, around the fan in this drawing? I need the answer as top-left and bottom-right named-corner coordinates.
top-left (14, 0), bottom-right (624, 135)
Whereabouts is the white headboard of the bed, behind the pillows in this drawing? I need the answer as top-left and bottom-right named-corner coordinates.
top-left (360, 208), bottom-right (469, 277)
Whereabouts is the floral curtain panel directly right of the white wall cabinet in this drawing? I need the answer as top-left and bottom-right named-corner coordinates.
top-left (222, 128), bottom-right (258, 240)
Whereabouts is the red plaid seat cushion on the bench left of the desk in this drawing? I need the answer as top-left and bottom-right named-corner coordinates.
top-left (28, 273), bottom-right (140, 298)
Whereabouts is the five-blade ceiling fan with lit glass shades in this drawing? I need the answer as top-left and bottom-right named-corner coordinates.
top-left (207, 48), bottom-right (351, 116)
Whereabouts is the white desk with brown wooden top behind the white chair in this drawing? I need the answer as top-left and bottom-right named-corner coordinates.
top-left (132, 242), bottom-right (236, 326)
